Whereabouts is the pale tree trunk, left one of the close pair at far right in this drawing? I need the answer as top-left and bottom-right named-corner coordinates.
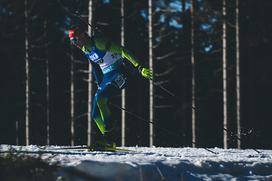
top-left (222, 0), bottom-right (228, 149)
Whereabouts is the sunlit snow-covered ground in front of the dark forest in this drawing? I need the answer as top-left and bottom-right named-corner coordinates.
top-left (0, 145), bottom-right (272, 181)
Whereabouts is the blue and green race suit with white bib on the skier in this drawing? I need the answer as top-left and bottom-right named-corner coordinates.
top-left (81, 38), bottom-right (141, 135)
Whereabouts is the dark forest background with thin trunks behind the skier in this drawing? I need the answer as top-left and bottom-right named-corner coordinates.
top-left (0, 0), bottom-right (272, 149)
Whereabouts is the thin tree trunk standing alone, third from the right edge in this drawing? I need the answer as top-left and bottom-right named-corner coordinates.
top-left (190, 0), bottom-right (196, 148)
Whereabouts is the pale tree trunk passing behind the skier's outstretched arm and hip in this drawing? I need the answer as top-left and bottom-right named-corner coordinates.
top-left (121, 0), bottom-right (126, 146)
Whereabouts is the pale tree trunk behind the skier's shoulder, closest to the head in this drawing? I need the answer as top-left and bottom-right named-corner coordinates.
top-left (87, 0), bottom-right (93, 145)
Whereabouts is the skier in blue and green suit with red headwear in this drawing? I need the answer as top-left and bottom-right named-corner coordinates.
top-left (68, 28), bottom-right (152, 146)
